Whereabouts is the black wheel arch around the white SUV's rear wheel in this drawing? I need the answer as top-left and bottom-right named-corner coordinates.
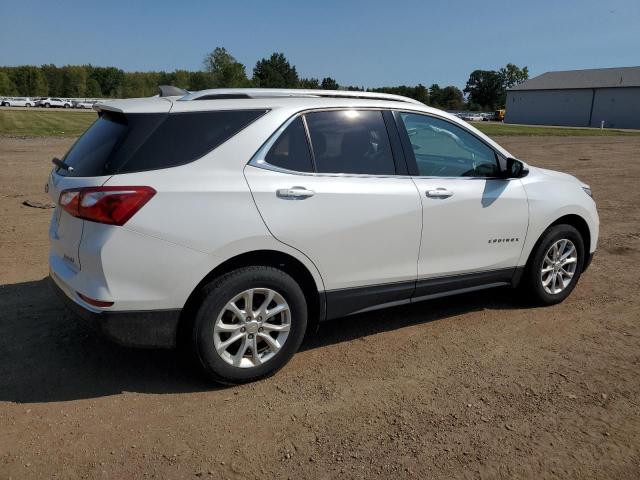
top-left (178, 250), bottom-right (326, 342)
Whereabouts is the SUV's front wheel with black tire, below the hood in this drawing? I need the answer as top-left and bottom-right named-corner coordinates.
top-left (520, 224), bottom-right (585, 305)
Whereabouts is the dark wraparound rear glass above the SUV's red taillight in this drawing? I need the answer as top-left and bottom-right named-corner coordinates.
top-left (57, 110), bottom-right (266, 177)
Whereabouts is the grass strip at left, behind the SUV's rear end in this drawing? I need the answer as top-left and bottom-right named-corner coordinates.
top-left (0, 109), bottom-right (97, 137)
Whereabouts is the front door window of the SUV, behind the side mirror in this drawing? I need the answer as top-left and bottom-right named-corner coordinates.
top-left (400, 113), bottom-right (500, 177)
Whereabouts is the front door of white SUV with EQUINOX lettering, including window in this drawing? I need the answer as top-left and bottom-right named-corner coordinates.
top-left (395, 112), bottom-right (529, 296)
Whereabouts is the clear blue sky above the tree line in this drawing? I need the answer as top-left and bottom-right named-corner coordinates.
top-left (0, 0), bottom-right (640, 88)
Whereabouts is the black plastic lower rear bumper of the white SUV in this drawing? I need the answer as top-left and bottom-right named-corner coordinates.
top-left (49, 276), bottom-right (181, 348)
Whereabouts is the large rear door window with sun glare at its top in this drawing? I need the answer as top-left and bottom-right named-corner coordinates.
top-left (306, 110), bottom-right (396, 175)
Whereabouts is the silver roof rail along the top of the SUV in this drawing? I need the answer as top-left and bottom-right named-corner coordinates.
top-left (179, 88), bottom-right (424, 105)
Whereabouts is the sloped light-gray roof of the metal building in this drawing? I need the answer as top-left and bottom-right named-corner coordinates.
top-left (509, 67), bottom-right (640, 90)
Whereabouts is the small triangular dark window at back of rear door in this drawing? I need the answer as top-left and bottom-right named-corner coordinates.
top-left (265, 117), bottom-right (313, 172)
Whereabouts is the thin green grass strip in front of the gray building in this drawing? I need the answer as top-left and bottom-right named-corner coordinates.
top-left (469, 122), bottom-right (640, 137)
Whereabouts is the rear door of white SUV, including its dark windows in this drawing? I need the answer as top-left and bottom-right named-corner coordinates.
top-left (245, 110), bottom-right (422, 318)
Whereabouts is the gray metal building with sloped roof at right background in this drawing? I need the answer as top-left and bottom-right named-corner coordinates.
top-left (504, 67), bottom-right (640, 128)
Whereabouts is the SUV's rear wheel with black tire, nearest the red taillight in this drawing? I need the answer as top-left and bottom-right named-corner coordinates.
top-left (191, 266), bottom-right (307, 385)
